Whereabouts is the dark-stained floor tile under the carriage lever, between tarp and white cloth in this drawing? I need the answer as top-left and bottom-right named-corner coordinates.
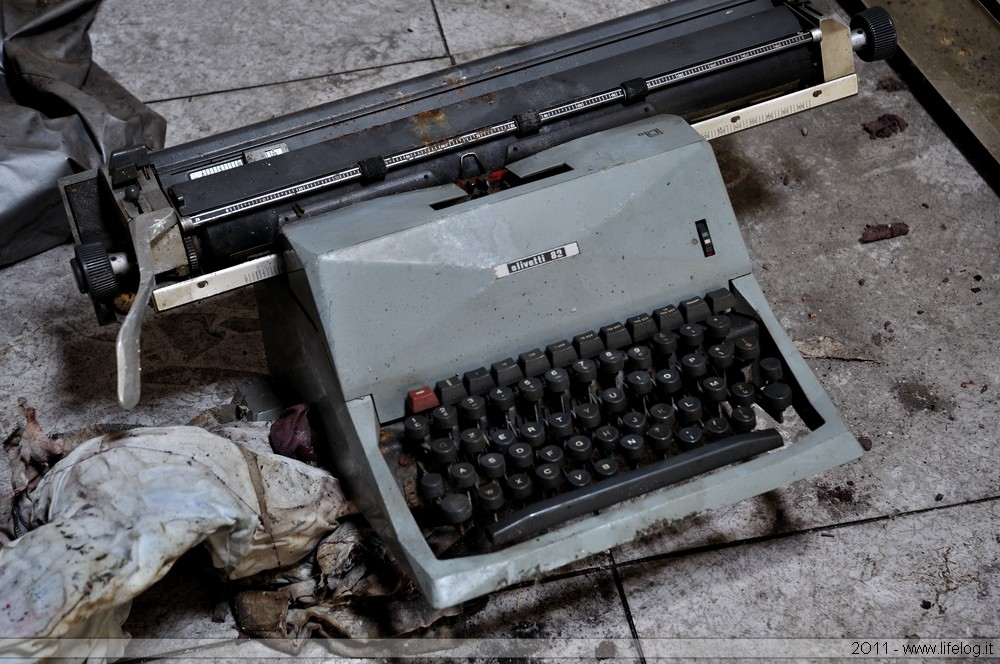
top-left (0, 245), bottom-right (267, 435)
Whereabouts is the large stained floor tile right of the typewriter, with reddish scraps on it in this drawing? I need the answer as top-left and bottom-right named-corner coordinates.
top-left (617, 58), bottom-right (1000, 559)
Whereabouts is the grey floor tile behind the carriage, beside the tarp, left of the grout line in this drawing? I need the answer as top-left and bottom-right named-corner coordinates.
top-left (90, 0), bottom-right (445, 101)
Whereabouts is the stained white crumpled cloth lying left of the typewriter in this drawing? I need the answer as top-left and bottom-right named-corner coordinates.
top-left (0, 427), bottom-right (349, 660)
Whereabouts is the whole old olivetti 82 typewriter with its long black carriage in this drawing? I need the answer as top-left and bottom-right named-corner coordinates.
top-left (60, 0), bottom-right (895, 607)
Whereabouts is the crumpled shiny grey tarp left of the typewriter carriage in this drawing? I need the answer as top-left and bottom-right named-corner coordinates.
top-left (0, 0), bottom-right (166, 266)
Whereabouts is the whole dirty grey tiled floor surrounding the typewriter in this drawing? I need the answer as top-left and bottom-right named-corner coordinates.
top-left (0, 0), bottom-right (1000, 659)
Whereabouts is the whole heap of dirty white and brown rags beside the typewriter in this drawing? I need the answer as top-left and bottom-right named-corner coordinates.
top-left (0, 404), bottom-right (470, 661)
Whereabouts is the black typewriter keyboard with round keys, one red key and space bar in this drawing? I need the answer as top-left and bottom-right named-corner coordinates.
top-left (395, 289), bottom-right (795, 549)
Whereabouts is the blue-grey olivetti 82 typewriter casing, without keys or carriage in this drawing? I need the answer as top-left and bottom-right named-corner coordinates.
top-left (257, 116), bottom-right (861, 606)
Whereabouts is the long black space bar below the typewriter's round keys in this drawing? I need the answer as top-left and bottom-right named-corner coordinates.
top-left (485, 429), bottom-right (782, 546)
